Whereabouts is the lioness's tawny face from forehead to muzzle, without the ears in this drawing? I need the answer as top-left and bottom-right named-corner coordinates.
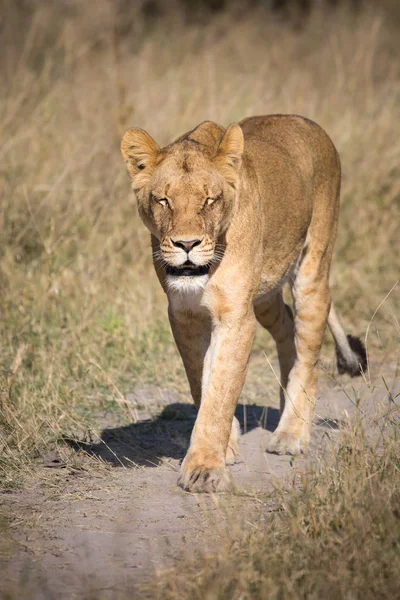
top-left (143, 150), bottom-right (235, 267)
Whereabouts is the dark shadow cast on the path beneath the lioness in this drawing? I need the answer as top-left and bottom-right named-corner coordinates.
top-left (63, 402), bottom-right (279, 467)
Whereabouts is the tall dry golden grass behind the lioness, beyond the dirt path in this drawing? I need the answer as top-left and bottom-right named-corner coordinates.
top-left (0, 0), bottom-right (400, 485)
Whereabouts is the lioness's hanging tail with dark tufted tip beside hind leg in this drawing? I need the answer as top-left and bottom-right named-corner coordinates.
top-left (328, 303), bottom-right (367, 377)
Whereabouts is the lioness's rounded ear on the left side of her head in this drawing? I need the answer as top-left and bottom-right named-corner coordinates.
top-left (121, 128), bottom-right (160, 177)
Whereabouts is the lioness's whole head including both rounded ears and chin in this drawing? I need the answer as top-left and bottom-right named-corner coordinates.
top-left (122, 125), bottom-right (243, 275)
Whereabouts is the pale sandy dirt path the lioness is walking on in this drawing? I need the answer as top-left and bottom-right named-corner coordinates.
top-left (0, 358), bottom-right (400, 599)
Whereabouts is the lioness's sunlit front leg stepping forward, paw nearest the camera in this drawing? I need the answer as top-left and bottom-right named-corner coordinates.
top-left (179, 310), bottom-right (256, 492)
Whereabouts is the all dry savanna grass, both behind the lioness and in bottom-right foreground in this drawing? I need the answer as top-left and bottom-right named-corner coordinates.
top-left (0, 0), bottom-right (400, 599)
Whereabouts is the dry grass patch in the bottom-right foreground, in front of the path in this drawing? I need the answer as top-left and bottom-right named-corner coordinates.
top-left (146, 424), bottom-right (400, 600)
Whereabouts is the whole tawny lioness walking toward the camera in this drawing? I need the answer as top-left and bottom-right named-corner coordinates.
top-left (121, 115), bottom-right (366, 492)
